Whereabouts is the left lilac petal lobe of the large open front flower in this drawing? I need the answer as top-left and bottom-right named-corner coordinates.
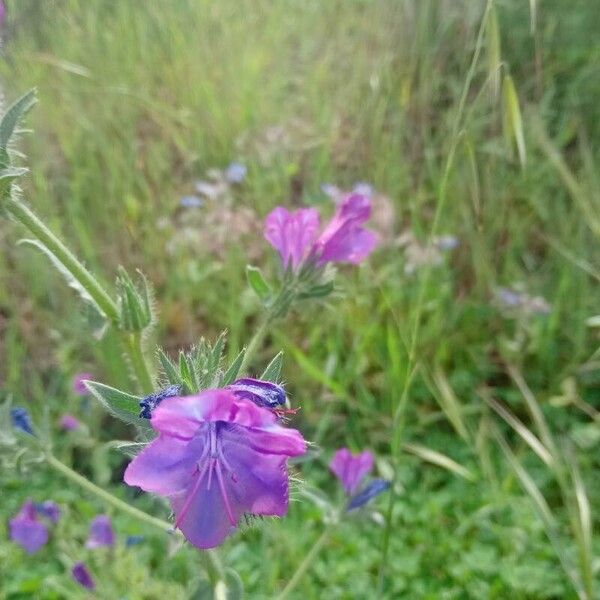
top-left (123, 434), bottom-right (205, 496)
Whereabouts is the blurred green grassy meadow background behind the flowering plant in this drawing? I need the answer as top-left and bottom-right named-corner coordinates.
top-left (0, 0), bottom-right (600, 600)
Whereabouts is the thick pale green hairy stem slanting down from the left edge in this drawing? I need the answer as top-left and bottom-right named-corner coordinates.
top-left (6, 200), bottom-right (119, 322)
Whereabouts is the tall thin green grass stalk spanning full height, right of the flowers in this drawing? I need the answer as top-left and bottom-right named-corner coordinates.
top-left (378, 0), bottom-right (494, 597)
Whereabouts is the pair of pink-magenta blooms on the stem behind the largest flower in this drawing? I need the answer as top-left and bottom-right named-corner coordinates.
top-left (264, 194), bottom-right (377, 270)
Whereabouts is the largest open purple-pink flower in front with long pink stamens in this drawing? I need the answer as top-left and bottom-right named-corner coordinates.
top-left (124, 389), bottom-right (306, 548)
